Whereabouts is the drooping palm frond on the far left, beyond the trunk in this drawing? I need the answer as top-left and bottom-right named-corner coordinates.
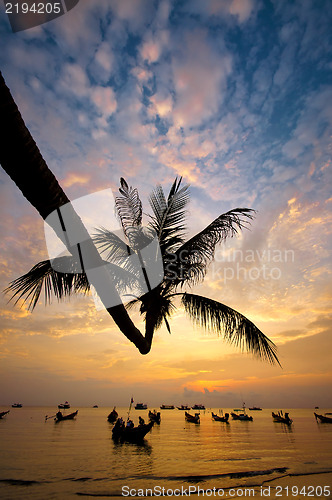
top-left (5, 256), bottom-right (90, 310)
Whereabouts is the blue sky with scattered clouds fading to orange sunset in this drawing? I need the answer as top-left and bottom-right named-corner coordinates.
top-left (0, 0), bottom-right (332, 408)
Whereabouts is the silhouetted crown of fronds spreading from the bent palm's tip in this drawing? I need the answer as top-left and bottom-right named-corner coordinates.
top-left (7, 178), bottom-right (280, 364)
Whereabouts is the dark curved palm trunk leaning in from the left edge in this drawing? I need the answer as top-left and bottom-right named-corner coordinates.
top-left (0, 73), bottom-right (151, 354)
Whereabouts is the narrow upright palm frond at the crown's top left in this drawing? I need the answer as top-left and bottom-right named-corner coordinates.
top-left (115, 177), bottom-right (142, 235)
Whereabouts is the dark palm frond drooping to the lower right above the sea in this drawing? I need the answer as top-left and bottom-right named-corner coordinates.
top-left (181, 293), bottom-right (280, 365)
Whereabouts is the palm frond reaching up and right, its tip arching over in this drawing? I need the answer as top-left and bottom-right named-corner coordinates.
top-left (173, 208), bottom-right (255, 285)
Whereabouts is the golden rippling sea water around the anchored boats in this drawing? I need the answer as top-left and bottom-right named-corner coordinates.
top-left (0, 407), bottom-right (332, 500)
